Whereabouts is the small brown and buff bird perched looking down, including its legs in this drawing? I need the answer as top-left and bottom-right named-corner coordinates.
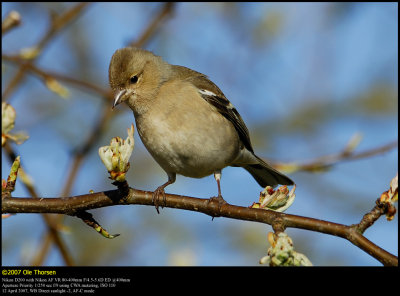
top-left (108, 47), bottom-right (294, 213)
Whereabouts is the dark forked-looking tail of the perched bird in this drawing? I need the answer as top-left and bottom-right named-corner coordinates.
top-left (243, 155), bottom-right (294, 187)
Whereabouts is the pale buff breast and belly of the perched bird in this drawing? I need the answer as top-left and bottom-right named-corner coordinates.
top-left (136, 102), bottom-right (239, 178)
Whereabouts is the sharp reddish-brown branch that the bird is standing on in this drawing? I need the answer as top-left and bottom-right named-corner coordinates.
top-left (2, 188), bottom-right (398, 266)
